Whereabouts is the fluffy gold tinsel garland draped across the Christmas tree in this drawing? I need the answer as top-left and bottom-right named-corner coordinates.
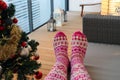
top-left (0, 24), bottom-right (21, 61)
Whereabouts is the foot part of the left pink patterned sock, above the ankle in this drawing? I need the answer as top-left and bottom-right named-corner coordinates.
top-left (53, 32), bottom-right (68, 62)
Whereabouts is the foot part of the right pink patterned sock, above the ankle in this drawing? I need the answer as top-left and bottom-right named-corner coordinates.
top-left (71, 31), bottom-right (87, 57)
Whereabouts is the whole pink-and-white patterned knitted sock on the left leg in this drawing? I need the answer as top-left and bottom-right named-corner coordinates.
top-left (45, 32), bottom-right (69, 80)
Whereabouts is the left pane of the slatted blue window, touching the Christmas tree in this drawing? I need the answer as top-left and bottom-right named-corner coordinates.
top-left (6, 0), bottom-right (30, 33)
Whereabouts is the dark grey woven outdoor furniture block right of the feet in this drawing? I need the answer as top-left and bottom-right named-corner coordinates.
top-left (83, 14), bottom-right (120, 44)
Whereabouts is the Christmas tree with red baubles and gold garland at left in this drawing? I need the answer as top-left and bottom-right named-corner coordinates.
top-left (0, 0), bottom-right (42, 80)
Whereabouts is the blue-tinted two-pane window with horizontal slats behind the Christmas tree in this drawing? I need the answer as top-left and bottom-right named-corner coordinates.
top-left (5, 0), bottom-right (51, 33)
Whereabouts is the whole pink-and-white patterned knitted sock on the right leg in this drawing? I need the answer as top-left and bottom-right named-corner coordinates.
top-left (71, 31), bottom-right (91, 80)
